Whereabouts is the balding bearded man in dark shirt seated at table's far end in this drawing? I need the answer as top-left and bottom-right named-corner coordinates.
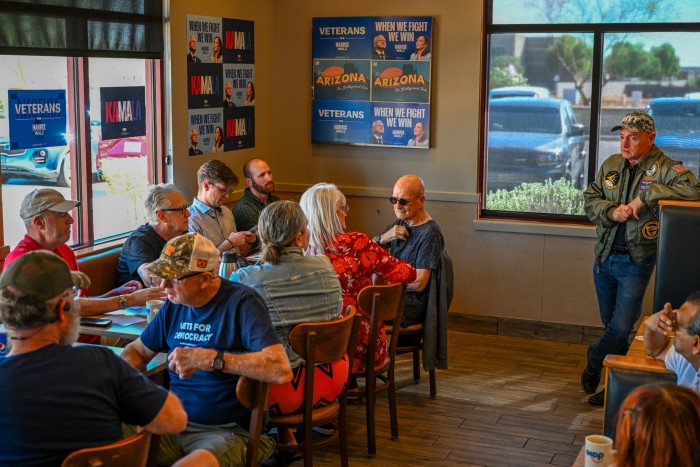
top-left (233, 159), bottom-right (279, 254)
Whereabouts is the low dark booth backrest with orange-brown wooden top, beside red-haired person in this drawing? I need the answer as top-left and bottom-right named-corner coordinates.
top-left (603, 355), bottom-right (676, 439)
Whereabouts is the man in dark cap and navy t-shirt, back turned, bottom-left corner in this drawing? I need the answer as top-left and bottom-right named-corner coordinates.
top-left (0, 250), bottom-right (187, 466)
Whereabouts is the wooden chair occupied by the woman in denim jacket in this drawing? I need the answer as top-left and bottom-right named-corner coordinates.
top-left (269, 309), bottom-right (360, 467)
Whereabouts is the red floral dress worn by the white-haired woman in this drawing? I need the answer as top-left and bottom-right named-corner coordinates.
top-left (326, 232), bottom-right (416, 373)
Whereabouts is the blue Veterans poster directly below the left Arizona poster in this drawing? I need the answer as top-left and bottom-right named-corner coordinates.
top-left (311, 99), bottom-right (371, 144)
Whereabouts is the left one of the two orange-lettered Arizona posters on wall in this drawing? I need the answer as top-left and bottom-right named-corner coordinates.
top-left (314, 60), bottom-right (370, 101)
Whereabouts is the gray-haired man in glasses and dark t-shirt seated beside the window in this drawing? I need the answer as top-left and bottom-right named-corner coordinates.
top-left (117, 184), bottom-right (190, 286)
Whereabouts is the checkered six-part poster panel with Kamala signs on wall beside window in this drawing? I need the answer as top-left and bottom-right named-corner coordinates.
top-left (187, 15), bottom-right (255, 156)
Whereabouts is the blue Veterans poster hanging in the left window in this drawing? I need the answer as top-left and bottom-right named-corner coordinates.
top-left (7, 89), bottom-right (67, 150)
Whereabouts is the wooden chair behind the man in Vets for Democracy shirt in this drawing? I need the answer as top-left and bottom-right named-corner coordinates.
top-left (236, 376), bottom-right (272, 467)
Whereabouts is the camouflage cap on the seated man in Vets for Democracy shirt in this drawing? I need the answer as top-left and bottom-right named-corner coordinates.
top-left (146, 232), bottom-right (219, 279)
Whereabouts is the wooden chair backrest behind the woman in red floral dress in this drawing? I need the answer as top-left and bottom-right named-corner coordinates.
top-left (357, 284), bottom-right (406, 369)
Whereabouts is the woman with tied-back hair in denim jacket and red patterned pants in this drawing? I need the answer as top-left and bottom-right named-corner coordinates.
top-left (231, 200), bottom-right (349, 415)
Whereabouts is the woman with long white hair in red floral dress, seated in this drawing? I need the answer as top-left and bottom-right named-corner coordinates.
top-left (299, 183), bottom-right (416, 373)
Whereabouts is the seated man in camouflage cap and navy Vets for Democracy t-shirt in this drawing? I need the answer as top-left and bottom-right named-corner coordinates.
top-left (122, 233), bottom-right (292, 466)
